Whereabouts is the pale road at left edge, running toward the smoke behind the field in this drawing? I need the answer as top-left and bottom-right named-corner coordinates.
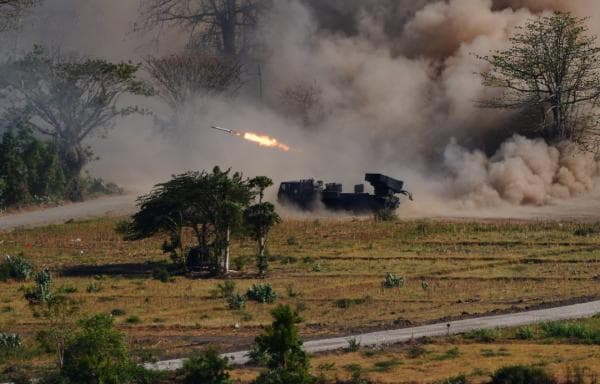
top-left (0, 195), bottom-right (136, 231)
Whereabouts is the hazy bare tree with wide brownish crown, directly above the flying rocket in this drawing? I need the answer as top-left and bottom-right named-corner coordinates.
top-left (146, 51), bottom-right (242, 111)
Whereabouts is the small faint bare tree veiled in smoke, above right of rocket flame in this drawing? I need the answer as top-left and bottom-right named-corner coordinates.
top-left (279, 82), bottom-right (325, 127)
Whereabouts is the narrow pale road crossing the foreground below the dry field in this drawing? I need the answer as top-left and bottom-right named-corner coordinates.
top-left (146, 300), bottom-right (600, 371)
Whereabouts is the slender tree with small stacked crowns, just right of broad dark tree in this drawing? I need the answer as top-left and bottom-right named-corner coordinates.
top-left (244, 176), bottom-right (281, 275)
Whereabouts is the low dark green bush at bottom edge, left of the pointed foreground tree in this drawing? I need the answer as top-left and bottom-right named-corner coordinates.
top-left (178, 349), bottom-right (232, 384)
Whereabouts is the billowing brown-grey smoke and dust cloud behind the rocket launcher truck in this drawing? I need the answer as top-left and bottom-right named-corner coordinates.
top-left (4, 0), bottom-right (600, 213)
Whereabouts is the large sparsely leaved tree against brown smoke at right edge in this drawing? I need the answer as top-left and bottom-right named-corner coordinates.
top-left (481, 13), bottom-right (600, 149)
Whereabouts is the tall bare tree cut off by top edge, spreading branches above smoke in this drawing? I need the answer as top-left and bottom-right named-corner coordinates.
top-left (138, 0), bottom-right (270, 57)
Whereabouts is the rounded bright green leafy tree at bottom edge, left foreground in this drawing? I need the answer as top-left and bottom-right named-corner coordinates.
top-left (61, 315), bottom-right (131, 384)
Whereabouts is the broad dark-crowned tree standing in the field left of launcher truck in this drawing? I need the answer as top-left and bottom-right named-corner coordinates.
top-left (122, 167), bottom-right (253, 272)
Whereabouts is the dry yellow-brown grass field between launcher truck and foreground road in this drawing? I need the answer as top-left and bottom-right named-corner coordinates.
top-left (0, 219), bottom-right (600, 382)
